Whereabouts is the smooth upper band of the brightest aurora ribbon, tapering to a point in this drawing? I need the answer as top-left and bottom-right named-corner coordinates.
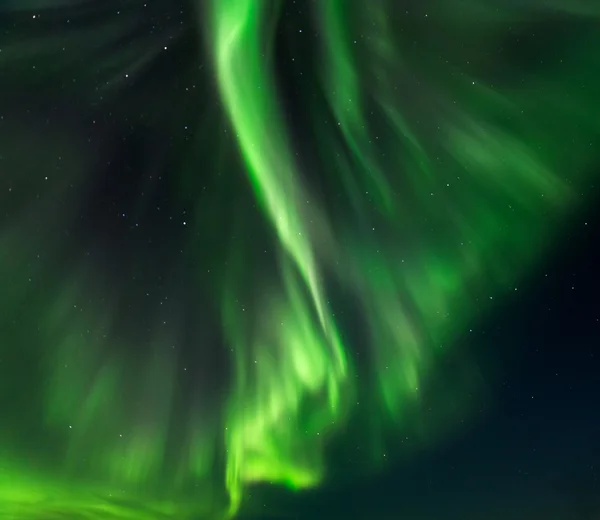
top-left (214, 0), bottom-right (326, 326)
